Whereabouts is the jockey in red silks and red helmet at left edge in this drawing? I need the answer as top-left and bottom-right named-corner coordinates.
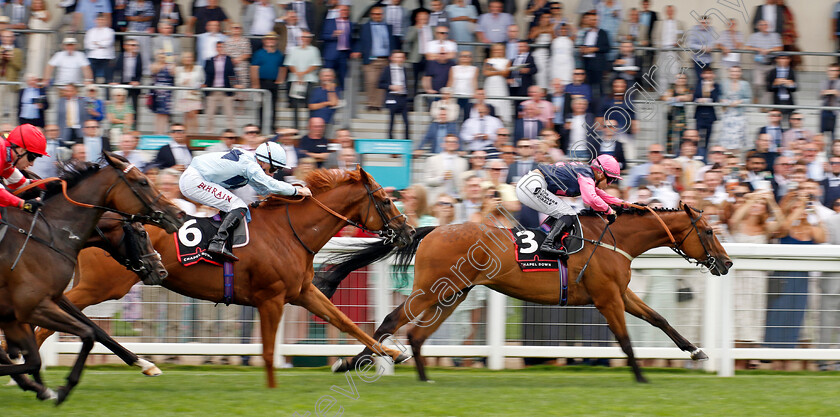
top-left (0, 124), bottom-right (49, 213)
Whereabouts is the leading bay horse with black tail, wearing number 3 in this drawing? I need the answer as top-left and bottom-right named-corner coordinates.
top-left (324, 203), bottom-right (732, 382)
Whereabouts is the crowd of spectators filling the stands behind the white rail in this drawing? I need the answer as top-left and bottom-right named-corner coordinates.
top-left (0, 0), bottom-right (840, 368)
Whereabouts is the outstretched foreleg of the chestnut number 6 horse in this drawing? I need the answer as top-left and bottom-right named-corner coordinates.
top-left (292, 285), bottom-right (411, 363)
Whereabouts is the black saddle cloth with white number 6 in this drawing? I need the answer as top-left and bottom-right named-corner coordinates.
top-left (174, 214), bottom-right (250, 266)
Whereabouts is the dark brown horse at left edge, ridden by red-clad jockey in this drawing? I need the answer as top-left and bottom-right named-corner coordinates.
top-left (0, 152), bottom-right (183, 404)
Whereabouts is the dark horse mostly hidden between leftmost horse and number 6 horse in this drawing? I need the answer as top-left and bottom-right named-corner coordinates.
top-left (0, 211), bottom-right (167, 389)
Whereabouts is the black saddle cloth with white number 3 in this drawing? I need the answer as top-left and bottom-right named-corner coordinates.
top-left (509, 219), bottom-right (583, 272)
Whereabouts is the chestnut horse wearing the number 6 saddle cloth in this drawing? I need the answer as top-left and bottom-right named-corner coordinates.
top-left (37, 168), bottom-right (413, 388)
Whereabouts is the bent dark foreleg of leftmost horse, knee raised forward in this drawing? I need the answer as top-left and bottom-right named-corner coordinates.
top-left (27, 299), bottom-right (95, 405)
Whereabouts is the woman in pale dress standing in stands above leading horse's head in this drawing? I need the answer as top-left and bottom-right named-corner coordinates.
top-left (720, 65), bottom-right (752, 152)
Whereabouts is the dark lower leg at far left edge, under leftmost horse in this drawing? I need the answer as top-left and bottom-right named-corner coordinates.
top-left (0, 321), bottom-right (56, 401)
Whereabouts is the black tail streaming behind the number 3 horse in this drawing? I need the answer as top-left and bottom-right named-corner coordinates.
top-left (312, 227), bottom-right (434, 298)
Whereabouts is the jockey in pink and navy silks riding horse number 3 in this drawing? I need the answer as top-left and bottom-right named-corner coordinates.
top-left (516, 155), bottom-right (627, 258)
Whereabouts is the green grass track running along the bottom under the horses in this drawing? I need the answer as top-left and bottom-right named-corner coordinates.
top-left (0, 366), bottom-right (840, 417)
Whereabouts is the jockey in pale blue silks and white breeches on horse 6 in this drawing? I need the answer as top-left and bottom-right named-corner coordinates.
top-left (178, 142), bottom-right (312, 261)
